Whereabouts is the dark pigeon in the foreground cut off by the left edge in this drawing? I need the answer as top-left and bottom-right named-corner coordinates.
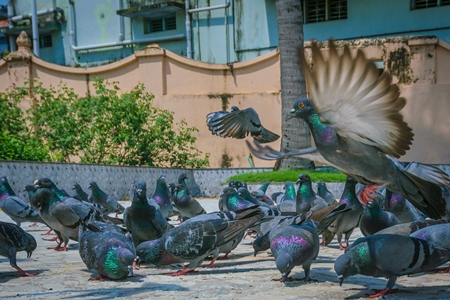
top-left (0, 221), bottom-right (37, 276)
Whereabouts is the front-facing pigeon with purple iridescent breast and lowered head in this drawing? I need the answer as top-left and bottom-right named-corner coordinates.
top-left (270, 220), bottom-right (319, 282)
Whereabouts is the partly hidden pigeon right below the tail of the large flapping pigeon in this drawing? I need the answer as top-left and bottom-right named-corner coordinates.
top-left (383, 190), bottom-right (426, 223)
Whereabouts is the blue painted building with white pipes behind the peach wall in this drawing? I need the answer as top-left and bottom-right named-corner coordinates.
top-left (0, 0), bottom-right (450, 66)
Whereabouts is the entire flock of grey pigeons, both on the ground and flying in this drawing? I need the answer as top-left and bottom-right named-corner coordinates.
top-left (0, 41), bottom-right (450, 297)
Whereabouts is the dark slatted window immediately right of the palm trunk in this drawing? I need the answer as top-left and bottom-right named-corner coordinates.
top-left (302, 0), bottom-right (348, 24)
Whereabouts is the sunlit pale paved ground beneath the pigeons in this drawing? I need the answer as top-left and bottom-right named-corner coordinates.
top-left (0, 198), bottom-right (450, 300)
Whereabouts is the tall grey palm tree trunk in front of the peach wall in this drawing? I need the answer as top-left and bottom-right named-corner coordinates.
top-left (276, 0), bottom-right (314, 169)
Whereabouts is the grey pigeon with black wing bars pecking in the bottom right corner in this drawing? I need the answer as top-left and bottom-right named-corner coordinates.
top-left (334, 234), bottom-right (450, 298)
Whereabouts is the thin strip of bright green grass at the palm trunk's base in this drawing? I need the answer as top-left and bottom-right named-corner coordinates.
top-left (227, 169), bottom-right (347, 183)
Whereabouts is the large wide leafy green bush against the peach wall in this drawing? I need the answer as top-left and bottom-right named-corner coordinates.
top-left (2, 78), bottom-right (209, 168)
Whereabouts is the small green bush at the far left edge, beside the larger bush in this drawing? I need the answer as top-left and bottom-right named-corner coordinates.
top-left (0, 86), bottom-right (49, 161)
